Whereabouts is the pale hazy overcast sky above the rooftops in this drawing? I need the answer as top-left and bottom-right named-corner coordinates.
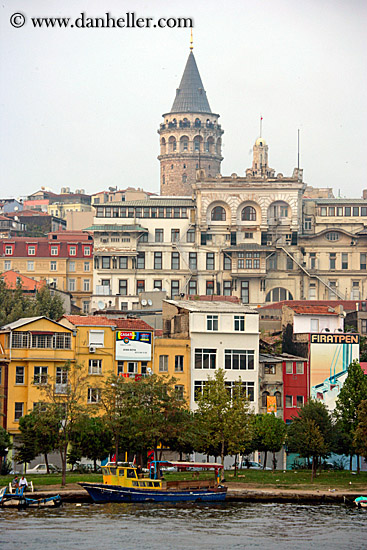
top-left (0, 0), bottom-right (367, 198)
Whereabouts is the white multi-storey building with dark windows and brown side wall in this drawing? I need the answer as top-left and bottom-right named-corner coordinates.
top-left (163, 300), bottom-right (259, 412)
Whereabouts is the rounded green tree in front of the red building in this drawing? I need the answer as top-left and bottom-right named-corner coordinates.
top-left (287, 399), bottom-right (333, 480)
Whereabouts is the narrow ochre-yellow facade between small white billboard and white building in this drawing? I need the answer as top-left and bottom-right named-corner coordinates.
top-left (154, 338), bottom-right (191, 404)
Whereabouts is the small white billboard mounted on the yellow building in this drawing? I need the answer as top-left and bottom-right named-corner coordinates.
top-left (115, 330), bottom-right (152, 361)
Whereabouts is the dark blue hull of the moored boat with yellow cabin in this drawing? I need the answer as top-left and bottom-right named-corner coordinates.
top-left (79, 483), bottom-right (227, 503)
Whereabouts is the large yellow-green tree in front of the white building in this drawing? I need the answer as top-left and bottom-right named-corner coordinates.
top-left (196, 369), bottom-right (252, 478)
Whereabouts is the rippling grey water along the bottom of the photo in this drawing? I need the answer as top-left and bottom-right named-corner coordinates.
top-left (0, 503), bottom-right (367, 550)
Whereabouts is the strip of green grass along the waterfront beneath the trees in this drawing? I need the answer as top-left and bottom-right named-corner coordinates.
top-left (0, 469), bottom-right (367, 494)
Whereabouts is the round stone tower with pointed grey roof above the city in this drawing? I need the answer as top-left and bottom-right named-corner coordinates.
top-left (158, 47), bottom-right (223, 196)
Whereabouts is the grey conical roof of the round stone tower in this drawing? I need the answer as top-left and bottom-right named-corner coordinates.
top-left (170, 51), bottom-right (211, 113)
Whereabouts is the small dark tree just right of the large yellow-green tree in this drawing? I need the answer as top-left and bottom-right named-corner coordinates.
top-left (254, 414), bottom-right (286, 471)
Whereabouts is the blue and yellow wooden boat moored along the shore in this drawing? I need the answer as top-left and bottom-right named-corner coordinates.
top-left (79, 461), bottom-right (227, 503)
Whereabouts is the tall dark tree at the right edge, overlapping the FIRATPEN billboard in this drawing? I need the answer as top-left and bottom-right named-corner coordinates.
top-left (335, 360), bottom-right (367, 473)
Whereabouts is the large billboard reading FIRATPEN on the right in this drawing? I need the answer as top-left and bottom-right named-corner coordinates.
top-left (310, 332), bottom-right (359, 387)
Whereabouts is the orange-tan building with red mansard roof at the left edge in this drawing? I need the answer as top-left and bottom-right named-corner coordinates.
top-left (0, 231), bottom-right (93, 313)
